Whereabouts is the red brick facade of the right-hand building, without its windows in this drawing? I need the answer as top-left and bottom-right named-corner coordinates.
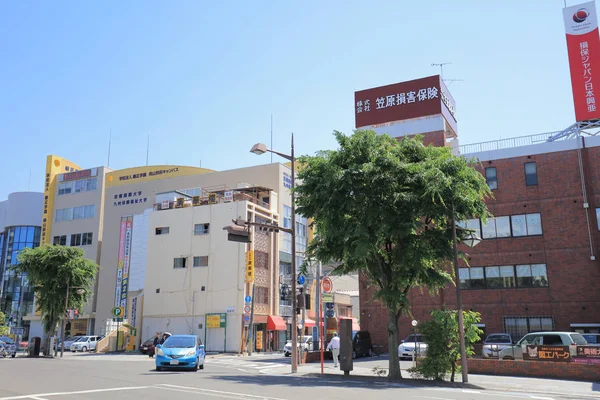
top-left (359, 142), bottom-right (600, 346)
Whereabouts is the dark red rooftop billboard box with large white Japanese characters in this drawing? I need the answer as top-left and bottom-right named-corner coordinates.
top-left (354, 75), bottom-right (456, 131)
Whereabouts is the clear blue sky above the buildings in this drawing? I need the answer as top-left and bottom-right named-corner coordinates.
top-left (0, 0), bottom-right (578, 200)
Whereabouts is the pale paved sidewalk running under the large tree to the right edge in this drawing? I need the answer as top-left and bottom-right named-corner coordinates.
top-left (264, 361), bottom-right (600, 399)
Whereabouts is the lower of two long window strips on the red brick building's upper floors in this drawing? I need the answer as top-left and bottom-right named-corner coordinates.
top-left (458, 264), bottom-right (548, 289)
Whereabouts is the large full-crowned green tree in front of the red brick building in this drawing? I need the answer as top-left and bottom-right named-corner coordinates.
top-left (296, 130), bottom-right (490, 379)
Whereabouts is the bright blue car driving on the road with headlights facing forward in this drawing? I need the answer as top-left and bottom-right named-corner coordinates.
top-left (156, 335), bottom-right (206, 371)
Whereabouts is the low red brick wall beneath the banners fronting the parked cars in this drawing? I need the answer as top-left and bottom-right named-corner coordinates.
top-left (469, 358), bottom-right (600, 382)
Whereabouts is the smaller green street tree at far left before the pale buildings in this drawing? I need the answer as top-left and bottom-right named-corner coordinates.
top-left (12, 246), bottom-right (98, 351)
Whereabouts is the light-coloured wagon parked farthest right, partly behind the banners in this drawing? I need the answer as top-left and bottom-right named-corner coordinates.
top-left (498, 332), bottom-right (588, 360)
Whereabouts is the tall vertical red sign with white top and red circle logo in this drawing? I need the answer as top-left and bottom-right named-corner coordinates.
top-left (563, 1), bottom-right (600, 121)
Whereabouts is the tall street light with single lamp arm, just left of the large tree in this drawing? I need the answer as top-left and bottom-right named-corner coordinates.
top-left (250, 133), bottom-right (298, 373)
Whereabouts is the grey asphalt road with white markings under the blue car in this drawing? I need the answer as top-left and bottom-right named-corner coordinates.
top-left (0, 354), bottom-right (584, 400)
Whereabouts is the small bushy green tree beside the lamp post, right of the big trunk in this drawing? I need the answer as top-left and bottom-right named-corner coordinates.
top-left (414, 310), bottom-right (483, 382)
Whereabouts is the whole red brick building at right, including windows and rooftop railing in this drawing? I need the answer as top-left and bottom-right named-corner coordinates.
top-left (360, 132), bottom-right (600, 346)
